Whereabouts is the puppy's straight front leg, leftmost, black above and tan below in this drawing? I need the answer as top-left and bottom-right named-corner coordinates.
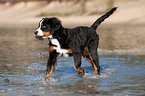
top-left (45, 50), bottom-right (58, 80)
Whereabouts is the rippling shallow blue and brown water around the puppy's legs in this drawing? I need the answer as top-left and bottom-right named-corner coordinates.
top-left (0, 27), bottom-right (145, 96)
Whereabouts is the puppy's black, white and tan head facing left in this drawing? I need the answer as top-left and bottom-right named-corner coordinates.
top-left (34, 17), bottom-right (61, 40)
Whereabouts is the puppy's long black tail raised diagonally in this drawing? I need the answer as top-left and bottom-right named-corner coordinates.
top-left (91, 7), bottom-right (118, 29)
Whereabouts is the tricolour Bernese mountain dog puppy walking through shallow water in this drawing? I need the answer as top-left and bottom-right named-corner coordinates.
top-left (34, 7), bottom-right (117, 80)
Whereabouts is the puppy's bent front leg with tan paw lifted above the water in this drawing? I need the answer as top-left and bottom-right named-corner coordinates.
top-left (73, 53), bottom-right (85, 75)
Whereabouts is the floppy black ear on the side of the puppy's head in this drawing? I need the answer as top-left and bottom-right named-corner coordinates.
top-left (50, 17), bottom-right (62, 34)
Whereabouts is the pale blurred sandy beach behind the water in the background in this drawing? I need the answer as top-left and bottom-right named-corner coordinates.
top-left (0, 0), bottom-right (145, 28)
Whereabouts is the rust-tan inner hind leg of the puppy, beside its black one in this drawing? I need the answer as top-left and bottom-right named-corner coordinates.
top-left (83, 47), bottom-right (99, 75)
